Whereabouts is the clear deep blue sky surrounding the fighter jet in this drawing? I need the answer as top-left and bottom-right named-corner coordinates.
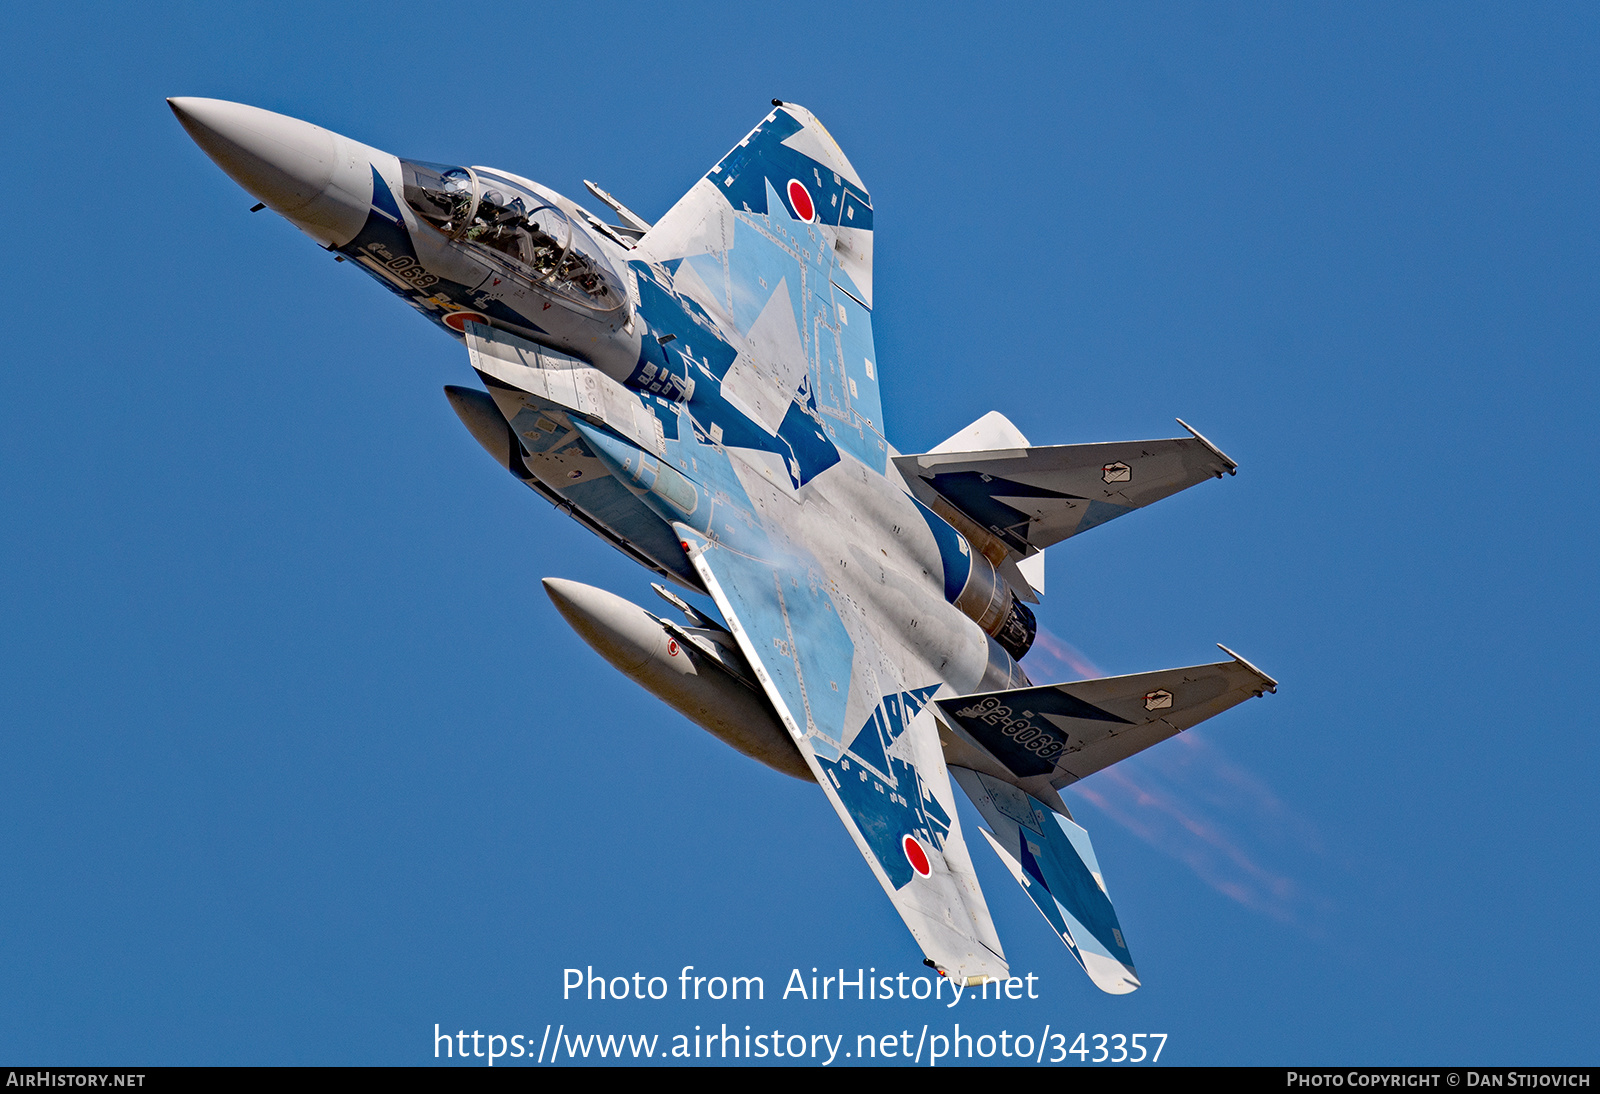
top-left (0, 3), bottom-right (1600, 1064)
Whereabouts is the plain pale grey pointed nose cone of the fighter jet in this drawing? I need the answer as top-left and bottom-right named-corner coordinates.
top-left (166, 98), bottom-right (386, 246)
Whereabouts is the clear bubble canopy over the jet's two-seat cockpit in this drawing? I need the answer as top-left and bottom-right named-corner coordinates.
top-left (400, 160), bottom-right (627, 312)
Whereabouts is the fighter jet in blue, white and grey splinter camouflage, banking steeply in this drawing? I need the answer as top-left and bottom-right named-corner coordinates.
top-left (168, 98), bottom-right (1277, 993)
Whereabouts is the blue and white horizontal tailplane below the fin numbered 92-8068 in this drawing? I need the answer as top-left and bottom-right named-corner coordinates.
top-left (950, 768), bottom-right (1139, 995)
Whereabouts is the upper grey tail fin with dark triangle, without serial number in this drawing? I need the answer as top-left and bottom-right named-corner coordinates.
top-left (894, 419), bottom-right (1238, 557)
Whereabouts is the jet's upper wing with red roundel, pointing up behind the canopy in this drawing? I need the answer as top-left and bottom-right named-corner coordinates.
top-left (634, 102), bottom-right (888, 473)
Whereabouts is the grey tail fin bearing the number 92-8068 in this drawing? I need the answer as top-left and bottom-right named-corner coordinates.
top-left (934, 648), bottom-right (1278, 787)
